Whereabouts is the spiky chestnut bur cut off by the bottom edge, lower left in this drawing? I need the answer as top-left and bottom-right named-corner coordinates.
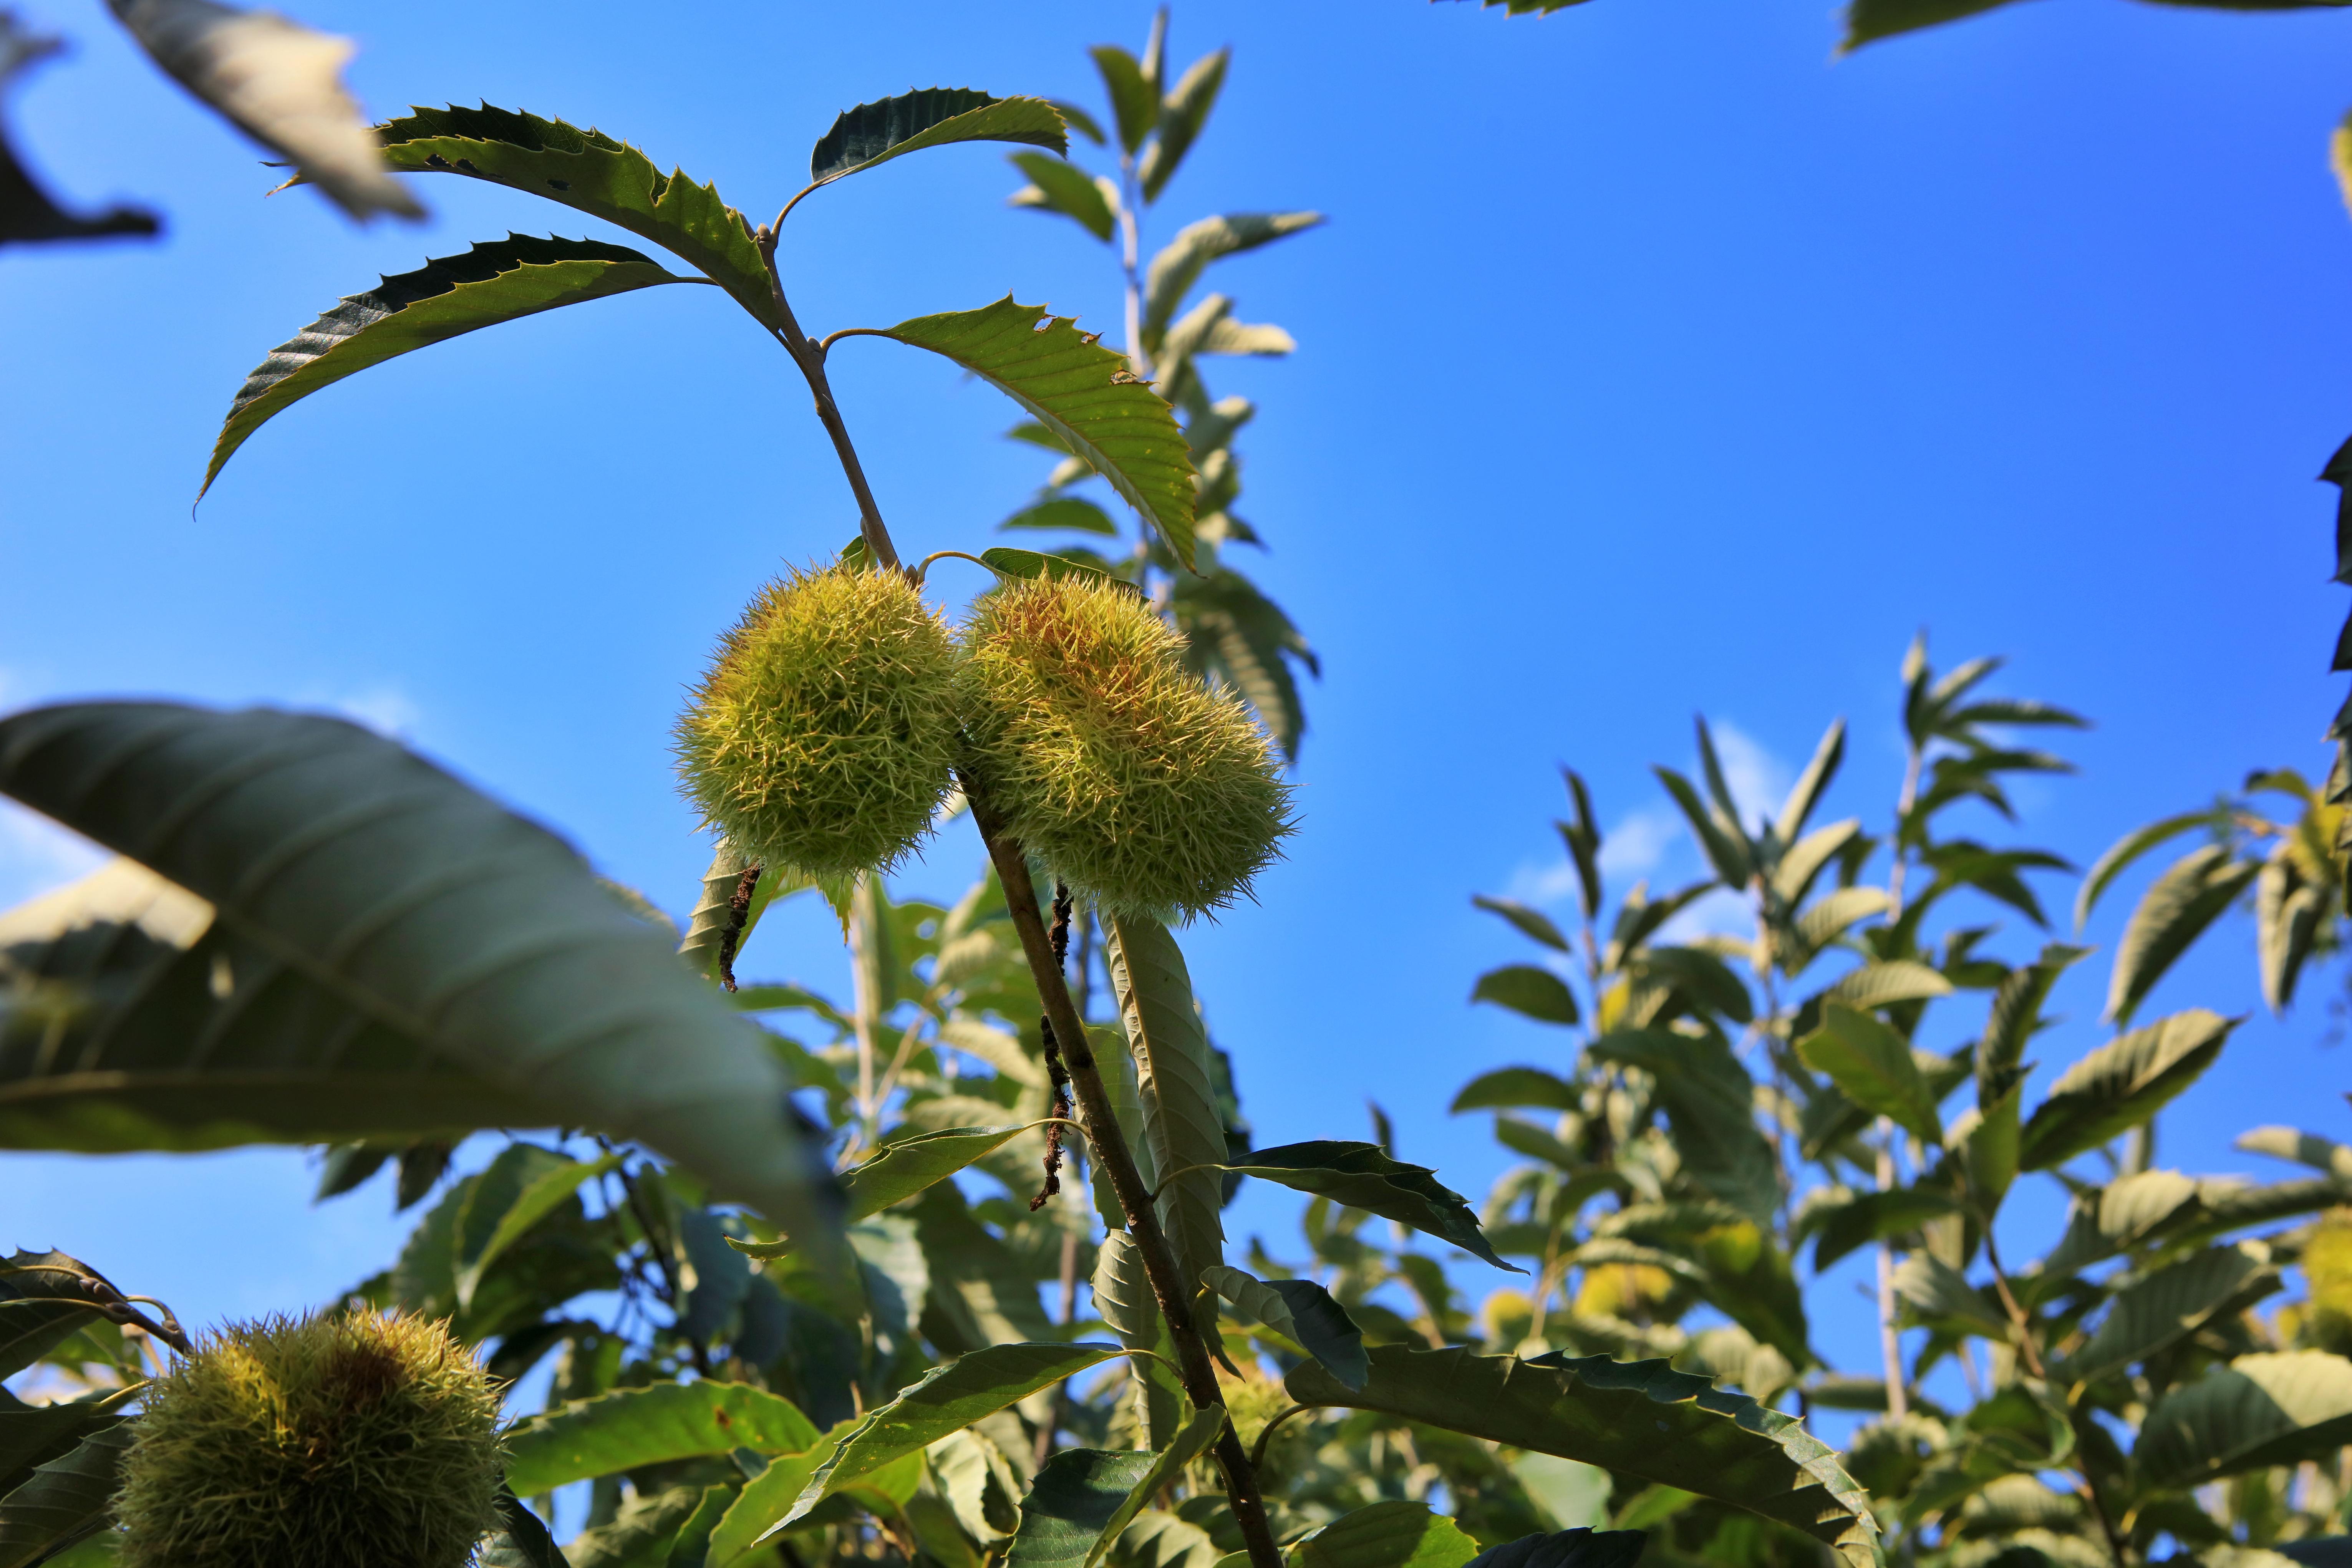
top-left (115, 1314), bottom-right (501, 1568)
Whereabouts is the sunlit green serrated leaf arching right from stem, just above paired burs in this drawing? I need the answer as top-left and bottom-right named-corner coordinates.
top-left (880, 294), bottom-right (1192, 571)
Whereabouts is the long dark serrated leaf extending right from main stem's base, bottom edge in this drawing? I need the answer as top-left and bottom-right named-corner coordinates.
top-left (1284, 1345), bottom-right (1877, 1568)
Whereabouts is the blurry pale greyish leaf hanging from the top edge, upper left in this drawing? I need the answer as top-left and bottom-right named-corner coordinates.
top-left (108, 0), bottom-right (426, 219)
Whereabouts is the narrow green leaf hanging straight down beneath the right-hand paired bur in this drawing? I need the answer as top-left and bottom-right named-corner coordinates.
top-left (1103, 915), bottom-right (1225, 1326)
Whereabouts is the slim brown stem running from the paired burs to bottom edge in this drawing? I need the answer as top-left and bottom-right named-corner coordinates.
top-left (960, 771), bottom-right (1282, 1568)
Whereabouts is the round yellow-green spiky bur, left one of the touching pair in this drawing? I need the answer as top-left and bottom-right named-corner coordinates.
top-left (677, 567), bottom-right (960, 877)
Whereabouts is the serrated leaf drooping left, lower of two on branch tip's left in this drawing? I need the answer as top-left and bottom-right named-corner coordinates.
top-left (197, 235), bottom-right (689, 501)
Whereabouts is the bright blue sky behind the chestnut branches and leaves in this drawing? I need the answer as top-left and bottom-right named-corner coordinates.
top-left (0, 0), bottom-right (2352, 1401)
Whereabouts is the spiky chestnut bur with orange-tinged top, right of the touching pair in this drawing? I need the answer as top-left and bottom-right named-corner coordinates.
top-left (964, 576), bottom-right (1291, 919)
